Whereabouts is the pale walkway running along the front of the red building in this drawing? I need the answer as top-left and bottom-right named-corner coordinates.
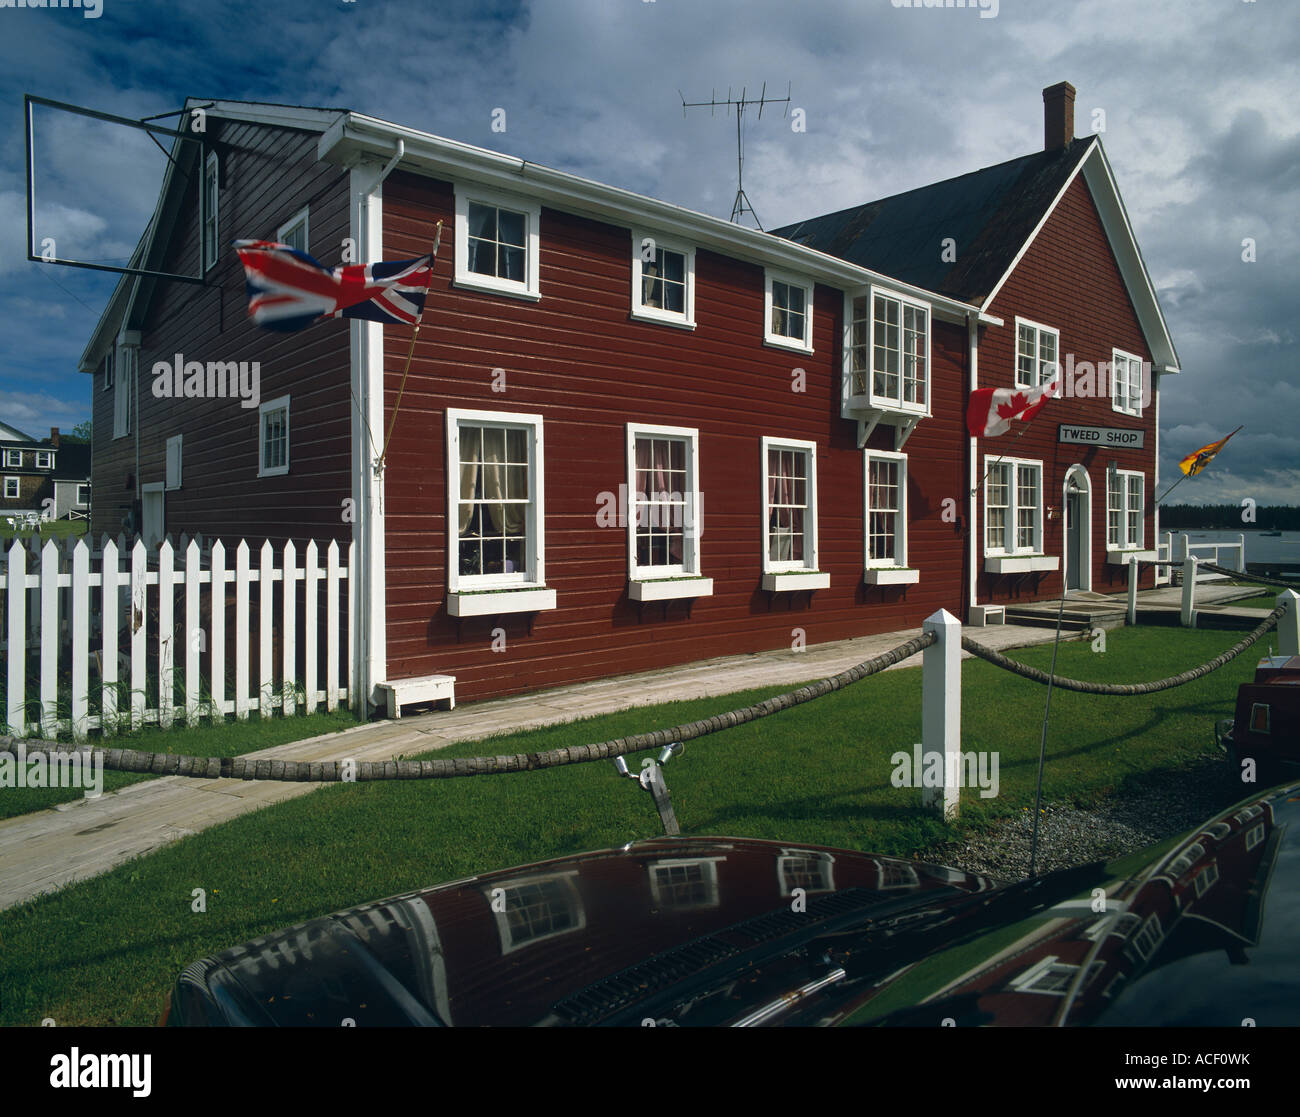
top-left (0, 624), bottom-right (1159, 909)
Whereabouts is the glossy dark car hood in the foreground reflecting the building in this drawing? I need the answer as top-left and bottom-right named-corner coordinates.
top-left (172, 787), bottom-right (1300, 1026)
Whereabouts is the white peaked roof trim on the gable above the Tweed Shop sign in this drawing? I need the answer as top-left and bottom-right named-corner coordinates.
top-left (982, 137), bottom-right (1179, 373)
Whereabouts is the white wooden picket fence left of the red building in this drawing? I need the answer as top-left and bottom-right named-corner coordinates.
top-left (0, 536), bottom-right (356, 740)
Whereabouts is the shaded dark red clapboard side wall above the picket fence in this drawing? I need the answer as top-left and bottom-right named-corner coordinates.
top-left (92, 118), bottom-right (351, 541)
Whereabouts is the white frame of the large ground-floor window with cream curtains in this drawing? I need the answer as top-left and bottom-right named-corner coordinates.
top-left (447, 407), bottom-right (555, 598)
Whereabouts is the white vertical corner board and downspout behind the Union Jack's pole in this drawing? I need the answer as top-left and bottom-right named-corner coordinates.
top-left (350, 139), bottom-right (406, 718)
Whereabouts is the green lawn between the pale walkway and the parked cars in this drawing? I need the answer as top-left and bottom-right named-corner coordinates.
top-left (0, 628), bottom-right (1255, 1026)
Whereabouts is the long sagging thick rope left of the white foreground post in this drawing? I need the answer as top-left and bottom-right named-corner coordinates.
top-left (0, 632), bottom-right (939, 783)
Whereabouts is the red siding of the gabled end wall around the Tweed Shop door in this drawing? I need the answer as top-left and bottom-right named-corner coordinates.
top-left (978, 176), bottom-right (1156, 602)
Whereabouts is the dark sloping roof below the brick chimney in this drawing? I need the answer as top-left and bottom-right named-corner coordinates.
top-left (772, 139), bottom-right (1095, 303)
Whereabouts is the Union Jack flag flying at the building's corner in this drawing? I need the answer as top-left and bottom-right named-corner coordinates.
top-left (234, 241), bottom-right (438, 332)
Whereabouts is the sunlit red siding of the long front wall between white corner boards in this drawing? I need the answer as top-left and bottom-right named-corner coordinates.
top-left (384, 173), bottom-right (966, 698)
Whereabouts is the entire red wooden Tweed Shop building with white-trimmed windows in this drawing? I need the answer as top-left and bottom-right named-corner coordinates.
top-left (82, 83), bottom-right (1178, 698)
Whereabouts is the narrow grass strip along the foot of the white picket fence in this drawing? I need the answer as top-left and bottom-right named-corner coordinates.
top-left (0, 709), bottom-right (358, 819)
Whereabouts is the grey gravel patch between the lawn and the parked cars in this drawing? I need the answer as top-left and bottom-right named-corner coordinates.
top-left (917, 756), bottom-right (1234, 880)
